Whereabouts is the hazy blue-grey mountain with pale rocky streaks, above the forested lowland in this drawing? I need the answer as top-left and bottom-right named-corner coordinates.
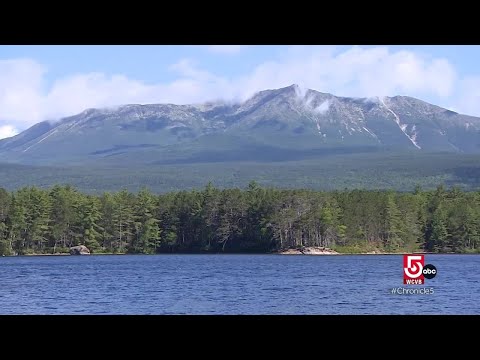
top-left (0, 85), bottom-right (480, 165)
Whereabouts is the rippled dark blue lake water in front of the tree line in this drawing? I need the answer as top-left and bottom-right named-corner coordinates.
top-left (0, 255), bottom-right (480, 314)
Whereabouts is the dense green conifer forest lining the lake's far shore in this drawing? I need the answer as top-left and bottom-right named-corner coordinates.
top-left (0, 182), bottom-right (480, 255)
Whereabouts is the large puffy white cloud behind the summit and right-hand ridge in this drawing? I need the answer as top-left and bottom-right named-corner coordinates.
top-left (236, 46), bottom-right (457, 97)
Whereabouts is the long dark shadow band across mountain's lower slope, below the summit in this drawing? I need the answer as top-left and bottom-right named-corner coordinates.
top-left (152, 145), bottom-right (379, 165)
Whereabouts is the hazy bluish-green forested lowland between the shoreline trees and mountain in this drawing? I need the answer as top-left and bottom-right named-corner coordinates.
top-left (0, 152), bottom-right (480, 195)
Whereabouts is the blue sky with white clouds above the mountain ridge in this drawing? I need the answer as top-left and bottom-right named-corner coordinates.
top-left (0, 45), bottom-right (480, 137)
